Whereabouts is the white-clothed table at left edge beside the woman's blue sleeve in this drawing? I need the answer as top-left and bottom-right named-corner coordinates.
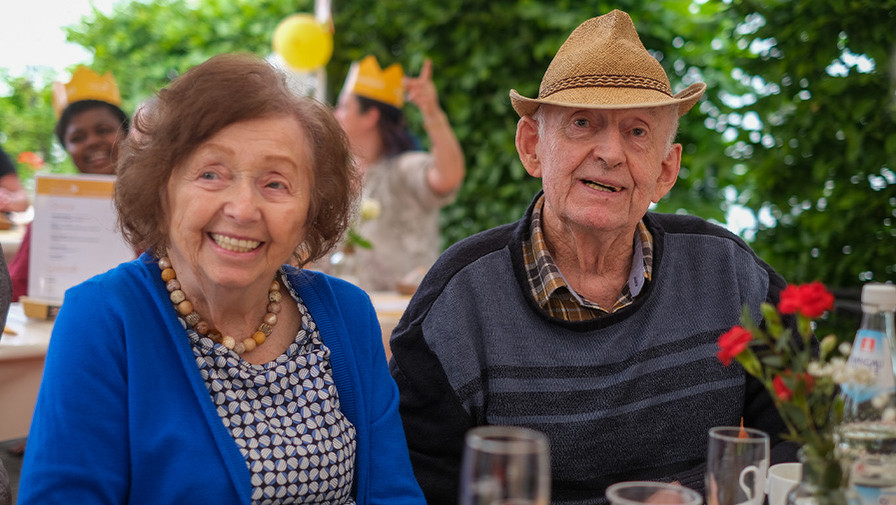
top-left (0, 303), bottom-right (53, 440)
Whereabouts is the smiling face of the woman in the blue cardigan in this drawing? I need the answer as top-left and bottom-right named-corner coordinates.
top-left (166, 116), bottom-right (313, 292)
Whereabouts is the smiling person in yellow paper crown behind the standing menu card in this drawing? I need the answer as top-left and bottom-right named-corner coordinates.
top-left (9, 67), bottom-right (129, 301)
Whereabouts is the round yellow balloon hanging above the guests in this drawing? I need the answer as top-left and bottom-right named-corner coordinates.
top-left (273, 14), bottom-right (333, 70)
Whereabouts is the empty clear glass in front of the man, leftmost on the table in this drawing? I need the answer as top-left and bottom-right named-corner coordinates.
top-left (460, 426), bottom-right (551, 505)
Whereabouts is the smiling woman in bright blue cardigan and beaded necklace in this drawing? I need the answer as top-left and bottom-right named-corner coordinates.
top-left (18, 54), bottom-right (425, 505)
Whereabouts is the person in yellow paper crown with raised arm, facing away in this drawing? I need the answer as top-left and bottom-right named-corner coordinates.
top-left (334, 55), bottom-right (465, 291)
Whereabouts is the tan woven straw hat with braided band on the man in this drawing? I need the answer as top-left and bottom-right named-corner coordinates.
top-left (510, 10), bottom-right (706, 117)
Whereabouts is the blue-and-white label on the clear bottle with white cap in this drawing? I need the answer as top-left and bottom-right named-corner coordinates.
top-left (843, 329), bottom-right (896, 402)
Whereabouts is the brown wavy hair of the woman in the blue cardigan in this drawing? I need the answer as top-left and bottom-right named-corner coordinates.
top-left (115, 54), bottom-right (360, 265)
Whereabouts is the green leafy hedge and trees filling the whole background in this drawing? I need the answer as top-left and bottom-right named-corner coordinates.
top-left (0, 0), bottom-right (896, 302)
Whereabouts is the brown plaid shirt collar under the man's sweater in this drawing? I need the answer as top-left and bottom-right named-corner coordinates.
top-left (523, 195), bottom-right (653, 321)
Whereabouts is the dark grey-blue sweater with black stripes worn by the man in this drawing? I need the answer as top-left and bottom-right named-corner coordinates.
top-left (390, 193), bottom-right (795, 505)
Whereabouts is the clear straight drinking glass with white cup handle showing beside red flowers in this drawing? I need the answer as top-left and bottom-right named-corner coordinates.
top-left (706, 426), bottom-right (769, 505)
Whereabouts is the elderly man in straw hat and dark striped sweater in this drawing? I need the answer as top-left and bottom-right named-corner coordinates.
top-left (390, 10), bottom-right (795, 504)
